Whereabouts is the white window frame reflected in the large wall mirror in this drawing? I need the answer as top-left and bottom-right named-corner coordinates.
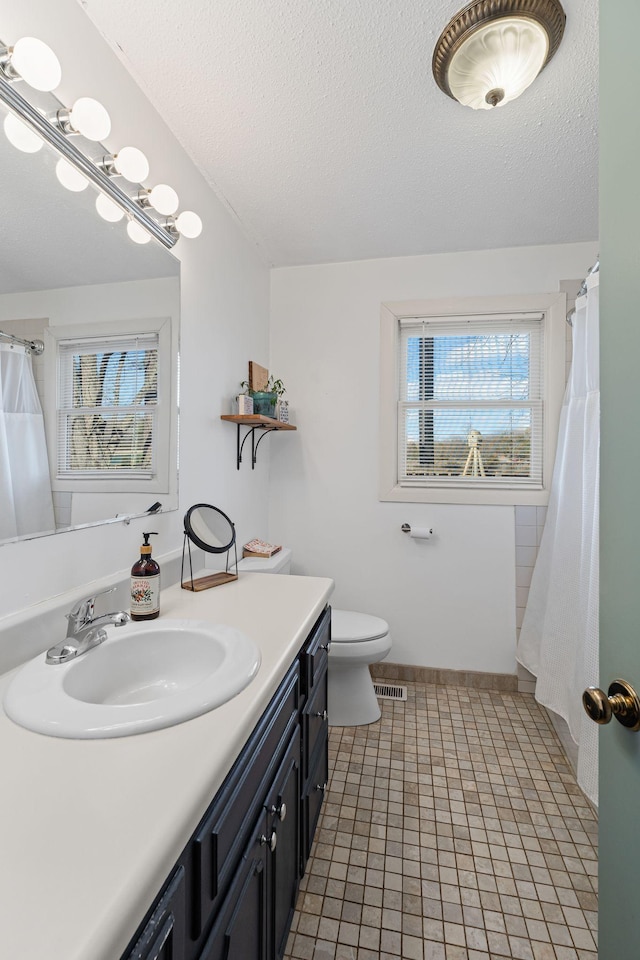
top-left (45, 317), bottom-right (177, 494)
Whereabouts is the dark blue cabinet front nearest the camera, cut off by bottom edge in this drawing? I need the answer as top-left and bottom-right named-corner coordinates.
top-left (123, 865), bottom-right (186, 960)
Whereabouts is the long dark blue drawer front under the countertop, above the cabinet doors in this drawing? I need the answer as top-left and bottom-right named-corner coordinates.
top-left (191, 663), bottom-right (300, 940)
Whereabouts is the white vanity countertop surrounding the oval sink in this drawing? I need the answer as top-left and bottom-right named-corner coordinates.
top-left (0, 574), bottom-right (333, 960)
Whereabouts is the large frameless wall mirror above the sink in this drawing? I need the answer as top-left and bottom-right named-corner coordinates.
top-left (0, 101), bottom-right (180, 543)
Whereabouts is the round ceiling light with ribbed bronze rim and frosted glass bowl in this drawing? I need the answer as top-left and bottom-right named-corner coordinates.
top-left (432, 0), bottom-right (566, 110)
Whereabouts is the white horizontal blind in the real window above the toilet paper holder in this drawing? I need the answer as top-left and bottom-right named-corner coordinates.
top-left (398, 314), bottom-right (544, 488)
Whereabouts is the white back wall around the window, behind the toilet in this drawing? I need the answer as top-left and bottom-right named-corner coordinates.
top-left (267, 243), bottom-right (597, 673)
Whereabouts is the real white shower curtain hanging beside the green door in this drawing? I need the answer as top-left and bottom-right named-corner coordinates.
top-left (518, 274), bottom-right (600, 803)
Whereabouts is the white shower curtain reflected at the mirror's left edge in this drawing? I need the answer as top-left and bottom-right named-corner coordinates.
top-left (0, 343), bottom-right (55, 540)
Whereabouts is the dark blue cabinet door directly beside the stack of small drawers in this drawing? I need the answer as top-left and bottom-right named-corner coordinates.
top-left (267, 727), bottom-right (301, 958)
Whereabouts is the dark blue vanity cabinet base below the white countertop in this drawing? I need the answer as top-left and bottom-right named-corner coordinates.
top-left (122, 607), bottom-right (331, 960)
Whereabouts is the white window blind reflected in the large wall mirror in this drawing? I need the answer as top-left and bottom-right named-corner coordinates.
top-left (57, 333), bottom-right (159, 479)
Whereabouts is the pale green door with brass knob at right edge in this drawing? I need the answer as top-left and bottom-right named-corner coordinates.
top-left (600, 0), bottom-right (640, 960)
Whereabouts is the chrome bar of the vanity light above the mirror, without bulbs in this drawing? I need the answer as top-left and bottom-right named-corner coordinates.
top-left (0, 75), bottom-right (178, 250)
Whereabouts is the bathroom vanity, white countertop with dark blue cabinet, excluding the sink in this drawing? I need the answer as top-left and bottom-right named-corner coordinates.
top-left (0, 574), bottom-right (333, 960)
